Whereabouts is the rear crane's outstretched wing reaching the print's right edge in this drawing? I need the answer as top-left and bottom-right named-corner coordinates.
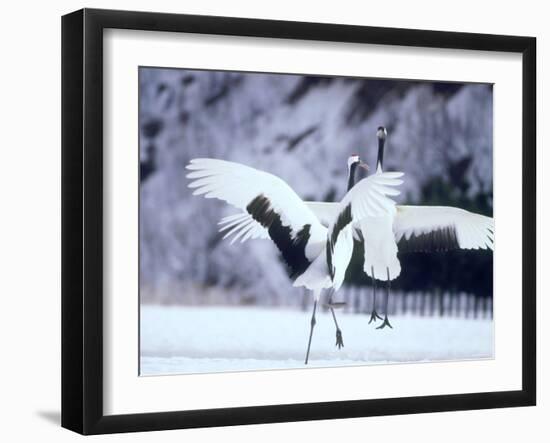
top-left (393, 206), bottom-right (494, 252)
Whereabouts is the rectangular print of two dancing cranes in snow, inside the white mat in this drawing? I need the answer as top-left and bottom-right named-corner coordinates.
top-left (139, 67), bottom-right (494, 376)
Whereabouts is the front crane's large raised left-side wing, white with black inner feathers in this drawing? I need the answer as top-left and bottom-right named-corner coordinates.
top-left (187, 158), bottom-right (326, 277)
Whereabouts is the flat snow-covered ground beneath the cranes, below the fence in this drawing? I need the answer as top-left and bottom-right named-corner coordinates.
top-left (140, 305), bottom-right (493, 375)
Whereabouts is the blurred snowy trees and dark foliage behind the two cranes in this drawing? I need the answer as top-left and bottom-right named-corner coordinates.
top-left (139, 67), bottom-right (493, 304)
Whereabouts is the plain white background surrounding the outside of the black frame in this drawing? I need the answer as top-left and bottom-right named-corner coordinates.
top-left (0, 0), bottom-right (550, 442)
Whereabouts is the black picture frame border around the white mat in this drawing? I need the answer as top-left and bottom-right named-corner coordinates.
top-left (62, 9), bottom-right (536, 434)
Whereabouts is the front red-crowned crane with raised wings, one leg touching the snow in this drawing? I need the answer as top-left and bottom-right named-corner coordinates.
top-left (187, 156), bottom-right (403, 364)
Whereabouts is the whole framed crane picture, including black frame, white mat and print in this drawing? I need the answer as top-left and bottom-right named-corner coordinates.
top-left (62, 9), bottom-right (536, 434)
